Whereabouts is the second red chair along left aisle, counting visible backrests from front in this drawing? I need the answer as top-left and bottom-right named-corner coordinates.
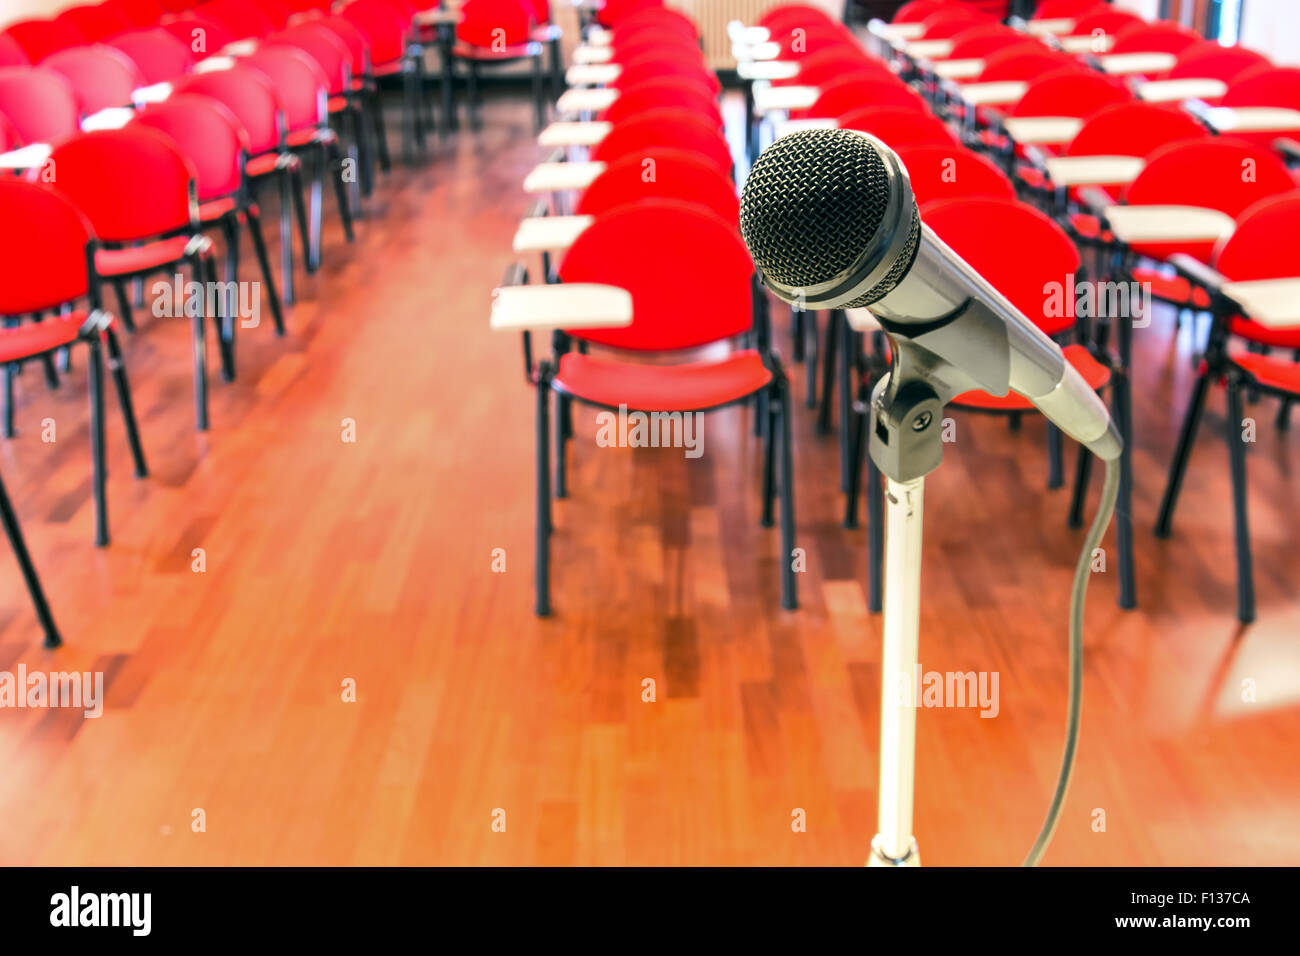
top-left (41, 127), bottom-right (217, 431)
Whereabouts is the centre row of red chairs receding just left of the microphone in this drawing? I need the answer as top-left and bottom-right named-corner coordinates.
top-left (496, 3), bottom-right (797, 614)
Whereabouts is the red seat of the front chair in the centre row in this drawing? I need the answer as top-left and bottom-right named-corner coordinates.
top-left (555, 349), bottom-right (772, 411)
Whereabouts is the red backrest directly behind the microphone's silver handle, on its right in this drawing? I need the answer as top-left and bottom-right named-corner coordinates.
top-left (920, 196), bottom-right (1079, 334)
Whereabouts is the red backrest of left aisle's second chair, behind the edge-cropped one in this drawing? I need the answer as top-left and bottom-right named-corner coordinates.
top-left (49, 126), bottom-right (196, 242)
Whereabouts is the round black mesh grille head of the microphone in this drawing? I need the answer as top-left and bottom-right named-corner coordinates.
top-left (740, 129), bottom-right (920, 307)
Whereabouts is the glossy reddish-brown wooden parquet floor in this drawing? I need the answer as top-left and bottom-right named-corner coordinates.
top-left (0, 100), bottom-right (1300, 865)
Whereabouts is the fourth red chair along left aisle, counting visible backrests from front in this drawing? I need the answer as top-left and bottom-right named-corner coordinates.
top-left (174, 66), bottom-right (311, 304)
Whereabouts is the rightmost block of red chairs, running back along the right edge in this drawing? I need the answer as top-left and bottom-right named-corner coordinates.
top-left (863, 0), bottom-right (1300, 622)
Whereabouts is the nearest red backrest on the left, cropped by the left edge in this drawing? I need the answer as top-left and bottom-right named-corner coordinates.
top-left (0, 177), bottom-right (91, 315)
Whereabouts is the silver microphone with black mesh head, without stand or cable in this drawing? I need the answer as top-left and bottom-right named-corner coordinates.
top-left (740, 129), bottom-right (1123, 460)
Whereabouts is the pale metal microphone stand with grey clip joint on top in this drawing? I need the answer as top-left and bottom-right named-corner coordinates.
top-left (867, 369), bottom-right (943, 866)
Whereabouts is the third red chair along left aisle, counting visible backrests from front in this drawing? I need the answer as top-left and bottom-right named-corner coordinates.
top-left (131, 94), bottom-right (285, 381)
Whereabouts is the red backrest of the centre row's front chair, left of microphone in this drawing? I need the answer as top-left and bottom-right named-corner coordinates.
top-left (560, 199), bottom-right (754, 351)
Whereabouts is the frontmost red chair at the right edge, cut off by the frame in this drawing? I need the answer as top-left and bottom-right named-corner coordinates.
top-left (1156, 191), bottom-right (1300, 623)
